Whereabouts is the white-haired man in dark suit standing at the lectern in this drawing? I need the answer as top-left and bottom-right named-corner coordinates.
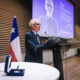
top-left (25, 19), bottom-right (43, 63)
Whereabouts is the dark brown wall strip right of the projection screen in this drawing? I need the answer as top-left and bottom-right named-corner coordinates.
top-left (74, 5), bottom-right (80, 40)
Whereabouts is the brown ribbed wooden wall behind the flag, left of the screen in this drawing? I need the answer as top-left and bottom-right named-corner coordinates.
top-left (0, 0), bottom-right (32, 62)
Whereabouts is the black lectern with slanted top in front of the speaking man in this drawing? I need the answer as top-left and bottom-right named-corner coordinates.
top-left (44, 37), bottom-right (68, 80)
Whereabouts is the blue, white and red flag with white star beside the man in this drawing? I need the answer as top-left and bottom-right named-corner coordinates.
top-left (8, 16), bottom-right (22, 62)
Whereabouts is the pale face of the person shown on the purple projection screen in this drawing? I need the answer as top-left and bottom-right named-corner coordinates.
top-left (45, 0), bottom-right (53, 16)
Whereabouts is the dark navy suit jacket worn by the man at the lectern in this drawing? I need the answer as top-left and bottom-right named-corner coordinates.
top-left (25, 31), bottom-right (42, 63)
